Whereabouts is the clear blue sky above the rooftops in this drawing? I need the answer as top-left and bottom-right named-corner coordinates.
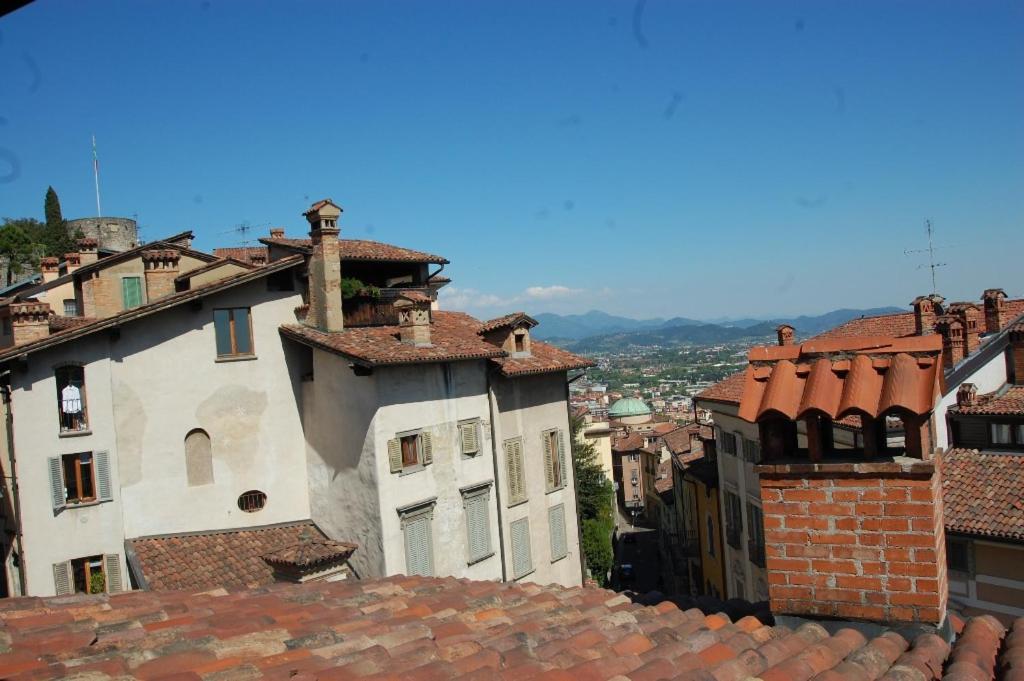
top-left (0, 0), bottom-right (1024, 317)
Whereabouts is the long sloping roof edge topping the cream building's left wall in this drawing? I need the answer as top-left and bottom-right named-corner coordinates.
top-left (0, 255), bottom-right (303, 363)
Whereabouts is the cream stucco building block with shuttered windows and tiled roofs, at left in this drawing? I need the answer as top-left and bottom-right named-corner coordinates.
top-left (0, 196), bottom-right (590, 595)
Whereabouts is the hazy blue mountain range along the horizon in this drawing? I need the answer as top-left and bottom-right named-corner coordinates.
top-left (534, 307), bottom-right (904, 351)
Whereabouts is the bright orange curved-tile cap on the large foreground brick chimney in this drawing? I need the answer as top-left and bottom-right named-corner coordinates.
top-left (738, 335), bottom-right (943, 423)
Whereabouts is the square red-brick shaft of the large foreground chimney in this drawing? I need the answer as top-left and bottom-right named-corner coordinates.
top-left (758, 457), bottom-right (947, 626)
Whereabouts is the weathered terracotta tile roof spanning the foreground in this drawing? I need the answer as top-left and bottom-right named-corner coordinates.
top-left (0, 577), bottom-right (1024, 681)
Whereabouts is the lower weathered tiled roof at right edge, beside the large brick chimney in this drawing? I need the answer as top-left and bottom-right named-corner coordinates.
top-left (942, 449), bottom-right (1024, 541)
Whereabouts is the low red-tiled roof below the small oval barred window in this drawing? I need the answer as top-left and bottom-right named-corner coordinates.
top-left (122, 520), bottom-right (354, 591)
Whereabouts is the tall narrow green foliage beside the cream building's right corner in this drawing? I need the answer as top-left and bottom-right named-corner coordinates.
top-left (570, 417), bottom-right (614, 587)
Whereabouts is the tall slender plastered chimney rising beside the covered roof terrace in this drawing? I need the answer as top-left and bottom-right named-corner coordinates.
top-left (301, 199), bottom-right (345, 333)
